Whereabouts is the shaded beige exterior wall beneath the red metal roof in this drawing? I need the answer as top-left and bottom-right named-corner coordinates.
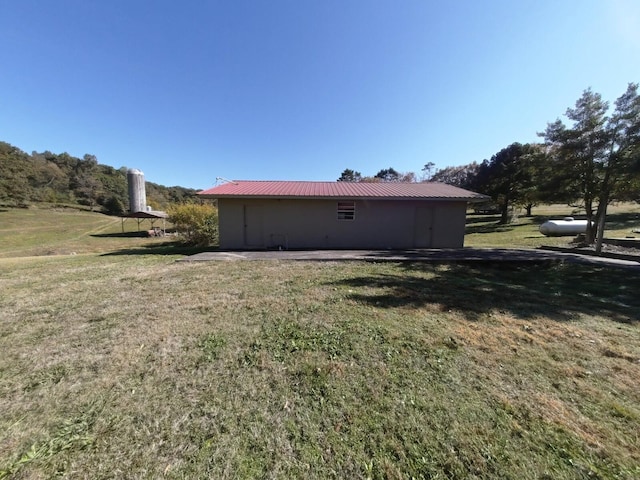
top-left (218, 198), bottom-right (466, 249)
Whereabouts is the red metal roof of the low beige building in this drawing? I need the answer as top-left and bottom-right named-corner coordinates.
top-left (200, 180), bottom-right (487, 201)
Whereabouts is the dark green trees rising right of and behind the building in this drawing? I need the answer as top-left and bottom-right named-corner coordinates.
top-left (338, 83), bottom-right (640, 249)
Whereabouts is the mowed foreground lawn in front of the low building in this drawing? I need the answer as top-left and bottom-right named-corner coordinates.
top-left (0, 255), bottom-right (640, 479)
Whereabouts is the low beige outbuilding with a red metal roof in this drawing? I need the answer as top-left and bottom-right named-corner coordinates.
top-left (200, 180), bottom-right (487, 249)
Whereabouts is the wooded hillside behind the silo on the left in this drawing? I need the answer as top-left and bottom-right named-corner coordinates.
top-left (0, 142), bottom-right (196, 215)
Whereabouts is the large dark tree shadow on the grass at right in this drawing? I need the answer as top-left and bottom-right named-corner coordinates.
top-left (330, 262), bottom-right (640, 323)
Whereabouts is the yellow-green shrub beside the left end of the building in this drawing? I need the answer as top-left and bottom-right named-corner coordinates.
top-left (167, 203), bottom-right (218, 246)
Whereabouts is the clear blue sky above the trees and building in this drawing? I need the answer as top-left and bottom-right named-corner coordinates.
top-left (0, 0), bottom-right (640, 189)
